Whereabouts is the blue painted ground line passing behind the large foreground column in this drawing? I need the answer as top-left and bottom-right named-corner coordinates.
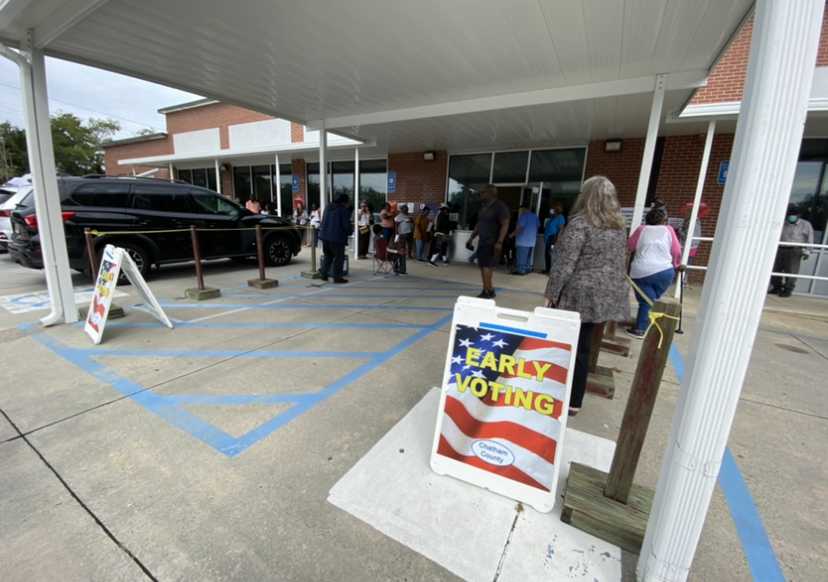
top-left (670, 344), bottom-right (785, 582)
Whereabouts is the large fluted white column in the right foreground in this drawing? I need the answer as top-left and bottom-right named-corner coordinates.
top-left (638, 0), bottom-right (825, 582)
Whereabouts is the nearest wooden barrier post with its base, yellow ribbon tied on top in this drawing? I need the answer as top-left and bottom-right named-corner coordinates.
top-left (561, 299), bottom-right (680, 552)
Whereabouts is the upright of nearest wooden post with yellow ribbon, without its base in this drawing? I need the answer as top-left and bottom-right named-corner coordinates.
top-left (604, 299), bottom-right (681, 503)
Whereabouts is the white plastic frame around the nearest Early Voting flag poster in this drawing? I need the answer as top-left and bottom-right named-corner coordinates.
top-left (430, 297), bottom-right (581, 513)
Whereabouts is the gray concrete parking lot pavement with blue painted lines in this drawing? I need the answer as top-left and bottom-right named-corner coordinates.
top-left (0, 256), bottom-right (828, 581)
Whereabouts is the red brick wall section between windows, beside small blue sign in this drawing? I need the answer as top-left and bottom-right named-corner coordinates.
top-left (388, 152), bottom-right (448, 209)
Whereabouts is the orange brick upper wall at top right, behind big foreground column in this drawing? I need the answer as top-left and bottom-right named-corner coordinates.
top-left (690, 11), bottom-right (828, 105)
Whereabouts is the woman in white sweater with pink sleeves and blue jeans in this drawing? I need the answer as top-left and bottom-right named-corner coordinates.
top-left (627, 206), bottom-right (681, 339)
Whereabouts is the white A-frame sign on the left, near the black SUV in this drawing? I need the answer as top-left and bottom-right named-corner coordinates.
top-left (83, 245), bottom-right (173, 345)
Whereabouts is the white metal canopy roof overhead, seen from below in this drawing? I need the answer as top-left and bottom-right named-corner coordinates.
top-left (0, 0), bottom-right (752, 151)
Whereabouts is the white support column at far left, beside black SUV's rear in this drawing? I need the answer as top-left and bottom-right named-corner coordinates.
top-left (20, 32), bottom-right (78, 326)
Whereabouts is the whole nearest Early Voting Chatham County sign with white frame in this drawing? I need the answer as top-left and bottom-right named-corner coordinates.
top-left (431, 297), bottom-right (580, 512)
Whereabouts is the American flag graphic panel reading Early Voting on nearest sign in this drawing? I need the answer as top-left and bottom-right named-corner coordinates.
top-left (437, 324), bottom-right (572, 492)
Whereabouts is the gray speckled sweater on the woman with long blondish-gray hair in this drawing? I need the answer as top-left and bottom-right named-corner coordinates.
top-left (546, 216), bottom-right (630, 322)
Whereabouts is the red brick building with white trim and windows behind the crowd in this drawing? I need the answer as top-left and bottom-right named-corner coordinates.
top-left (106, 13), bottom-right (828, 295)
